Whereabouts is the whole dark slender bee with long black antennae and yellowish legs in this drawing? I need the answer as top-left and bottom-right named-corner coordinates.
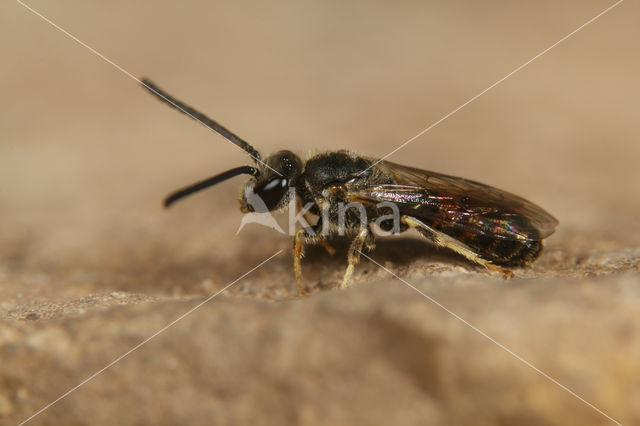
top-left (142, 79), bottom-right (558, 294)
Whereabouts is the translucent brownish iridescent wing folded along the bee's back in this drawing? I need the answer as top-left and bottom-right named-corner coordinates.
top-left (348, 161), bottom-right (558, 241)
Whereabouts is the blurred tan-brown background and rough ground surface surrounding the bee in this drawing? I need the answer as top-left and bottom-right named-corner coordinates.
top-left (0, 0), bottom-right (640, 425)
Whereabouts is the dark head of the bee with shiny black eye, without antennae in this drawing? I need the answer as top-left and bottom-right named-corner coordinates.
top-left (240, 151), bottom-right (302, 213)
